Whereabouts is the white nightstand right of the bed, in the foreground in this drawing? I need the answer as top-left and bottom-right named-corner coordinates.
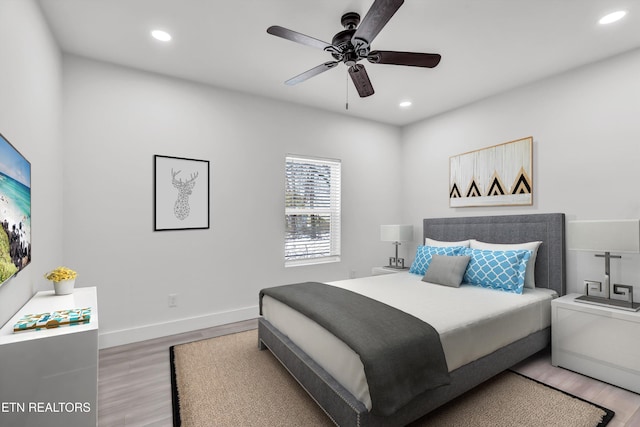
top-left (551, 294), bottom-right (640, 393)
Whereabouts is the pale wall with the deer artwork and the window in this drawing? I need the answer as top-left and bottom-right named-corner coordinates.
top-left (63, 56), bottom-right (401, 346)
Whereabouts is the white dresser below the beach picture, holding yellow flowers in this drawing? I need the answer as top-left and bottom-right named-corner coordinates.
top-left (0, 288), bottom-right (98, 427)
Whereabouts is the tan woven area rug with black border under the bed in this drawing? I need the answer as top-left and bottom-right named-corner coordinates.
top-left (171, 330), bottom-right (613, 427)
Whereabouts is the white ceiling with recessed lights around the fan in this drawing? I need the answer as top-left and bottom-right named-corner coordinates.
top-left (39, 0), bottom-right (640, 125)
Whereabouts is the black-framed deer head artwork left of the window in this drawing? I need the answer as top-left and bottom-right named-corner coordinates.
top-left (154, 155), bottom-right (211, 231)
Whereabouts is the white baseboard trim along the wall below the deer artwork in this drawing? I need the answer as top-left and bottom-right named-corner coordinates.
top-left (98, 305), bottom-right (258, 349)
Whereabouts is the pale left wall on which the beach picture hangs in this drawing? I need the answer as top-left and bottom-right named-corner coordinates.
top-left (0, 0), bottom-right (63, 325)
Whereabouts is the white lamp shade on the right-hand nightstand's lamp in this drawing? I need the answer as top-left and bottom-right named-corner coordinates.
top-left (567, 219), bottom-right (640, 253)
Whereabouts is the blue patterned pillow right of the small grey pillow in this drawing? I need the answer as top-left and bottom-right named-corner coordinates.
top-left (462, 248), bottom-right (531, 294)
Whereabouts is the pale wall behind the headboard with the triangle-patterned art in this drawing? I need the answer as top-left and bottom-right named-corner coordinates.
top-left (402, 50), bottom-right (640, 294)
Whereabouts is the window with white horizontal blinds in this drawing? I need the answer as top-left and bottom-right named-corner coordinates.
top-left (284, 156), bottom-right (341, 266)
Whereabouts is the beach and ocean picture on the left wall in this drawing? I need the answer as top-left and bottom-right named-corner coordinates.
top-left (0, 134), bottom-right (31, 286)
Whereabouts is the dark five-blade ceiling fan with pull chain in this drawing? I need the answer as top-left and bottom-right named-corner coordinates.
top-left (267, 0), bottom-right (440, 98)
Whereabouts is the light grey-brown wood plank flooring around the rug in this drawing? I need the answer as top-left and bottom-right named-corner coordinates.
top-left (98, 320), bottom-right (640, 427)
